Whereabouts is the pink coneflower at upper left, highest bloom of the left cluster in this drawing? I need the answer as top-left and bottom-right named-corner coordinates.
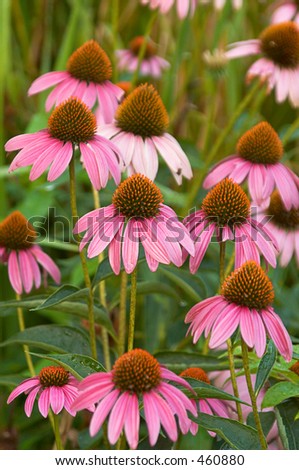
top-left (28, 40), bottom-right (123, 122)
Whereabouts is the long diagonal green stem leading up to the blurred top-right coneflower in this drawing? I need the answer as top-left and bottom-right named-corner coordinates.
top-left (187, 81), bottom-right (261, 207)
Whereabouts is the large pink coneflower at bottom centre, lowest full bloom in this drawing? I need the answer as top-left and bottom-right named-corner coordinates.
top-left (72, 349), bottom-right (197, 449)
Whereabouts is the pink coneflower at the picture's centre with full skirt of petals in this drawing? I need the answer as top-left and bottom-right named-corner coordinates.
top-left (74, 174), bottom-right (194, 274)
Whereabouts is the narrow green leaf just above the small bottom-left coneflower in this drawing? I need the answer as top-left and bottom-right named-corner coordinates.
top-left (31, 353), bottom-right (106, 380)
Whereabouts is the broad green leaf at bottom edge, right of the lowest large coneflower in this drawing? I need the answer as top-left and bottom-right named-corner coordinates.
top-left (189, 413), bottom-right (261, 450)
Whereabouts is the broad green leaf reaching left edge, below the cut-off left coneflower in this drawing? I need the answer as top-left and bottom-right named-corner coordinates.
top-left (0, 325), bottom-right (90, 354)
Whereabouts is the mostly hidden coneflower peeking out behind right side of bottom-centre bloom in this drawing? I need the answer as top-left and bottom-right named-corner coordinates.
top-left (180, 367), bottom-right (229, 436)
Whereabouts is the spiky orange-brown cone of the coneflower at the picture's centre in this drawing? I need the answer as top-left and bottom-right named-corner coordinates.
top-left (112, 173), bottom-right (163, 219)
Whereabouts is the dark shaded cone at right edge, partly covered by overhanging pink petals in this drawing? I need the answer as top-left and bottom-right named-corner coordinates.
top-left (267, 190), bottom-right (299, 230)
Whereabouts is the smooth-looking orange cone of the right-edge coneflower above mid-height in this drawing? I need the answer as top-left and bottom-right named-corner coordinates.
top-left (237, 122), bottom-right (283, 164)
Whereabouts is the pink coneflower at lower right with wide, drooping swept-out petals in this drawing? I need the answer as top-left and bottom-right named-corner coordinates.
top-left (185, 261), bottom-right (293, 361)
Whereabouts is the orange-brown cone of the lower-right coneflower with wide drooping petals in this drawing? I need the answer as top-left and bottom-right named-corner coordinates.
top-left (221, 261), bottom-right (274, 310)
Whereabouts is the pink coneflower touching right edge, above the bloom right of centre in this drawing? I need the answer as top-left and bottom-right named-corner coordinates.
top-left (203, 122), bottom-right (299, 210)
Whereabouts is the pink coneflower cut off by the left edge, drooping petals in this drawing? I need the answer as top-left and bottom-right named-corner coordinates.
top-left (0, 211), bottom-right (60, 294)
